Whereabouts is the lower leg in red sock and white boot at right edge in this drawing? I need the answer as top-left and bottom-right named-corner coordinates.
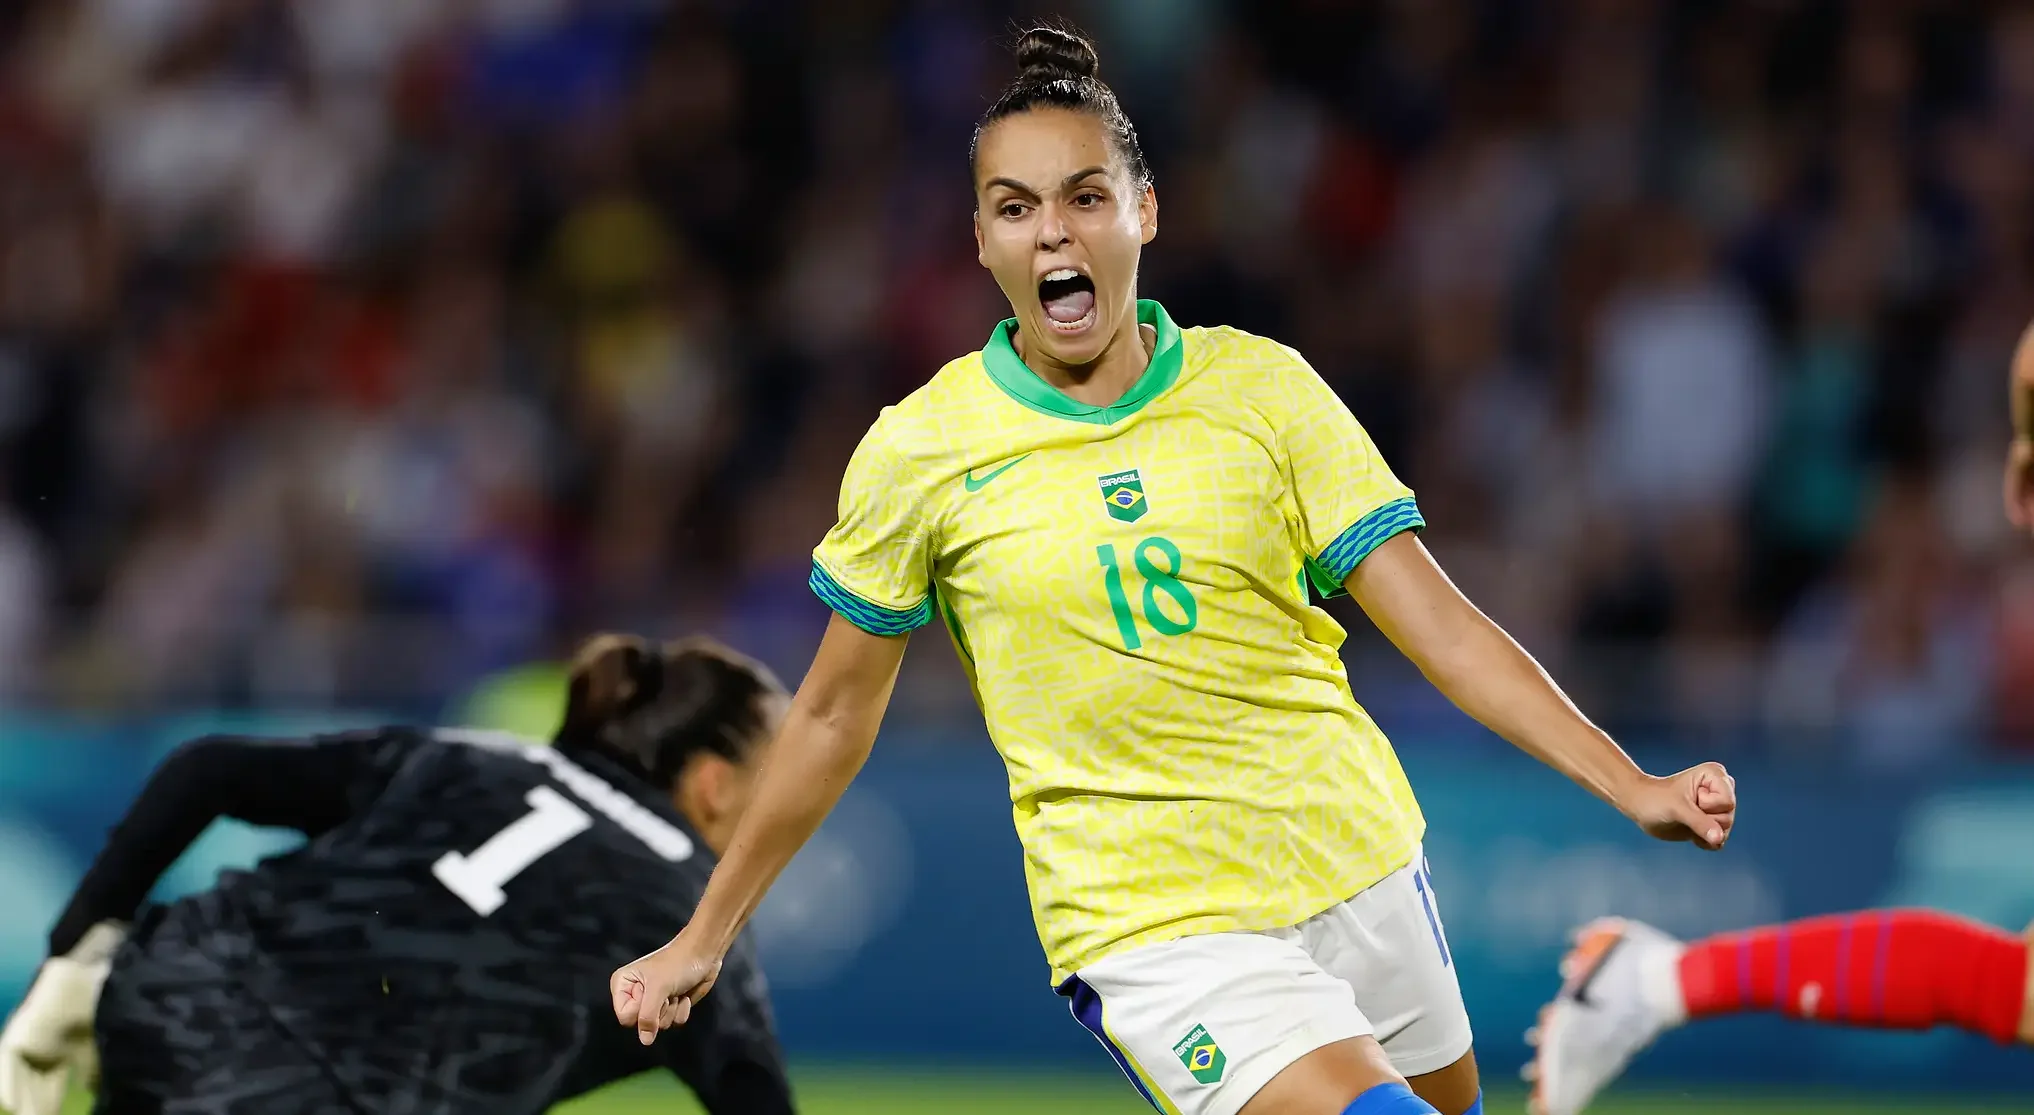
top-left (1526, 909), bottom-right (2034, 1115)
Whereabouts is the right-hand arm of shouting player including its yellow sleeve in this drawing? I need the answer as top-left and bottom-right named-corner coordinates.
top-left (1273, 354), bottom-right (1737, 848)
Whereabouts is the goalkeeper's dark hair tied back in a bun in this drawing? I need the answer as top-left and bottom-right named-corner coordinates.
top-left (555, 635), bottom-right (787, 789)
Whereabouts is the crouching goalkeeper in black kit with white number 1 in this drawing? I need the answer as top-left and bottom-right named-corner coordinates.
top-left (0, 635), bottom-right (793, 1115)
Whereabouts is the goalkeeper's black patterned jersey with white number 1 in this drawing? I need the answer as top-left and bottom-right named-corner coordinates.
top-left (69, 728), bottom-right (791, 1115)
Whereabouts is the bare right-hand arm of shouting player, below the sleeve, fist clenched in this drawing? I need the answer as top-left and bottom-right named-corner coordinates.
top-left (1347, 533), bottom-right (1737, 850)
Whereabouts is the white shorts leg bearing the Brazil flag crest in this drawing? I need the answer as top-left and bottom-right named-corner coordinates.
top-left (1060, 930), bottom-right (1371, 1115)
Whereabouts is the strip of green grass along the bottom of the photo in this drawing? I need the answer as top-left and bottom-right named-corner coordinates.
top-left (65, 1066), bottom-right (2034, 1115)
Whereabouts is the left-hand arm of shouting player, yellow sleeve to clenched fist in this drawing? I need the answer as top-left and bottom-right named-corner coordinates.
top-left (608, 411), bottom-right (934, 1044)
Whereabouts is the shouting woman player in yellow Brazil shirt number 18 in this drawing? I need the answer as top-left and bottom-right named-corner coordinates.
top-left (612, 31), bottom-right (1735, 1115)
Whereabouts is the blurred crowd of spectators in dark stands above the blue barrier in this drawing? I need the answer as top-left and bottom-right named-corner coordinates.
top-left (0, 0), bottom-right (2009, 765)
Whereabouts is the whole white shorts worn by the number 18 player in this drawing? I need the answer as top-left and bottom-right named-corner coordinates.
top-left (1060, 853), bottom-right (1471, 1115)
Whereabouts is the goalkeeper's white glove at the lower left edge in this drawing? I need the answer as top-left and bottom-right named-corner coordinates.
top-left (0, 922), bottom-right (126, 1115)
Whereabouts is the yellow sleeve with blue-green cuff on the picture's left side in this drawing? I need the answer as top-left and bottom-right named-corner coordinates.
top-left (812, 421), bottom-right (932, 635)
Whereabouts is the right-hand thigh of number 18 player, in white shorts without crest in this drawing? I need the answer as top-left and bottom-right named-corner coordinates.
top-left (1300, 855), bottom-right (1475, 1090)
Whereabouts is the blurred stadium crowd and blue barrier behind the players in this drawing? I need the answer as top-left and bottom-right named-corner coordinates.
top-left (0, 0), bottom-right (2034, 1111)
